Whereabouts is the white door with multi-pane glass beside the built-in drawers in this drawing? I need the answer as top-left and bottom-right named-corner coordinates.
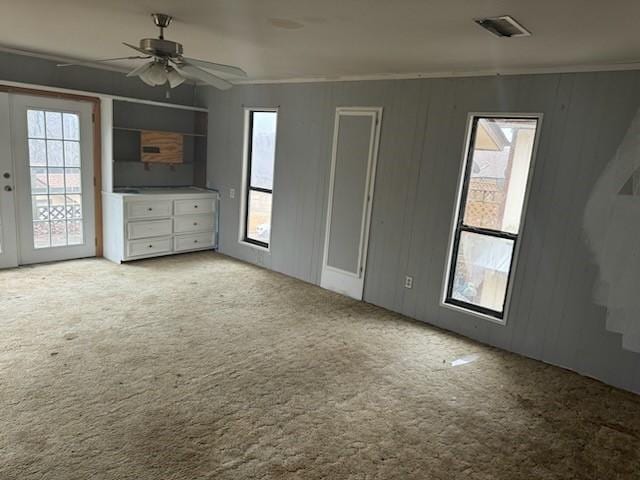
top-left (10, 95), bottom-right (96, 264)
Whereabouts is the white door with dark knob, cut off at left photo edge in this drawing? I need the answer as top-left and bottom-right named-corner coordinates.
top-left (0, 92), bottom-right (18, 268)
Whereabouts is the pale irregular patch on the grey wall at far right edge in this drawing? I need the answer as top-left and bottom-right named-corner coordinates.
top-left (584, 106), bottom-right (640, 352)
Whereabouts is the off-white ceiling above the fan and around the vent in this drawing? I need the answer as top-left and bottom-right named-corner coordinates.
top-left (0, 0), bottom-right (640, 80)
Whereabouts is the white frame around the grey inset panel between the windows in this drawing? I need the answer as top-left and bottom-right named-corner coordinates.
top-left (320, 107), bottom-right (383, 300)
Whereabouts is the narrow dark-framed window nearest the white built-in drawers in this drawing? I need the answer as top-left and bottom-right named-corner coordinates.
top-left (242, 109), bottom-right (278, 248)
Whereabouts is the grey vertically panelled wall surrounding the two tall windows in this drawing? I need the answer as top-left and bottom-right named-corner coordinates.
top-left (197, 72), bottom-right (640, 392)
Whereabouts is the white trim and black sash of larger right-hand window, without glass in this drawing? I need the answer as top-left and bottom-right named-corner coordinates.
top-left (440, 112), bottom-right (543, 325)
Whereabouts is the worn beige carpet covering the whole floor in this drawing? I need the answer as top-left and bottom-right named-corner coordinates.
top-left (0, 252), bottom-right (640, 480)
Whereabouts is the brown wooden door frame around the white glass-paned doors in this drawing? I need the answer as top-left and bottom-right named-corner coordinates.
top-left (0, 83), bottom-right (103, 257)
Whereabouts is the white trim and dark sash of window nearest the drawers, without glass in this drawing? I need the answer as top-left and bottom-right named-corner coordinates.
top-left (239, 107), bottom-right (279, 252)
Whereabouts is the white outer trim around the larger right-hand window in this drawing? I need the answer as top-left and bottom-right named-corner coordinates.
top-left (440, 112), bottom-right (543, 325)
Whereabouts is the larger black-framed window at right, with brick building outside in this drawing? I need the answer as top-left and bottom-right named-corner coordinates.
top-left (445, 116), bottom-right (540, 322)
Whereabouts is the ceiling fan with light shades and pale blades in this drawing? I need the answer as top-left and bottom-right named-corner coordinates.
top-left (58, 13), bottom-right (247, 90)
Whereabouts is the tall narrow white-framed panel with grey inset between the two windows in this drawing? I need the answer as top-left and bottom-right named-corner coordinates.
top-left (320, 107), bottom-right (382, 300)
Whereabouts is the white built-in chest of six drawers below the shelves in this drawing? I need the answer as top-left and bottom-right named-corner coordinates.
top-left (102, 187), bottom-right (219, 263)
